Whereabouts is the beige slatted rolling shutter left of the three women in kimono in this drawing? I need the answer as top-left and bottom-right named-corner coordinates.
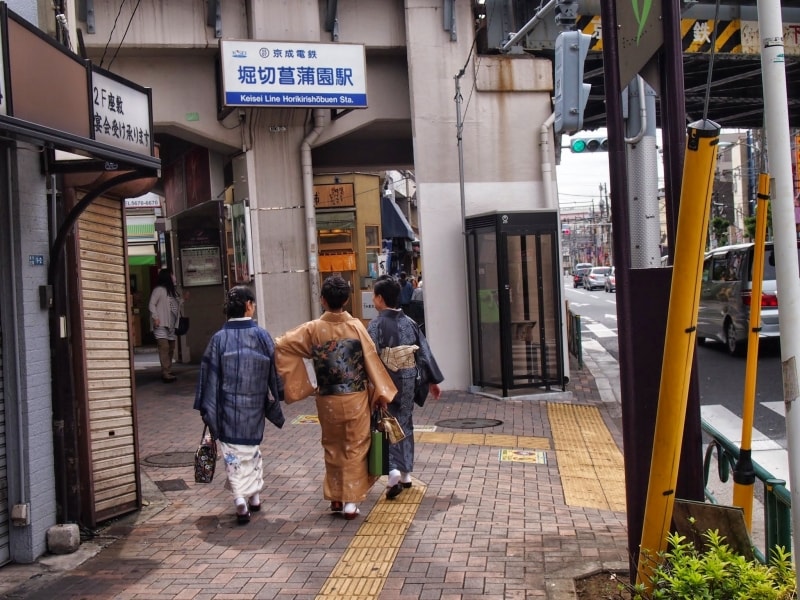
top-left (75, 198), bottom-right (141, 524)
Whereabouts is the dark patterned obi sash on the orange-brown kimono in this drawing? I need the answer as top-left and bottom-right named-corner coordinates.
top-left (312, 339), bottom-right (367, 396)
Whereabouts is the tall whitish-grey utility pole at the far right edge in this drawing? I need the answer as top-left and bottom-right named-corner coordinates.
top-left (757, 0), bottom-right (800, 562)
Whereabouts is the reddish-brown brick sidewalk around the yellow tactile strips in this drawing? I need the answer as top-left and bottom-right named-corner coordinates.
top-left (0, 354), bottom-right (627, 600)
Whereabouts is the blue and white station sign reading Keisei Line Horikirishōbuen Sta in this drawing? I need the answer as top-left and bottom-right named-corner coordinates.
top-left (219, 40), bottom-right (367, 108)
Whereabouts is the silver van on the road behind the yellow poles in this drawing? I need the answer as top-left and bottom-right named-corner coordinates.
top-left (697, 242), bottom-right (792, 354)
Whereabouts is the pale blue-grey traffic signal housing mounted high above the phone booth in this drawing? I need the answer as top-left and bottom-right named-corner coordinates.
top-left (553, 31), bottom-right (592, 133)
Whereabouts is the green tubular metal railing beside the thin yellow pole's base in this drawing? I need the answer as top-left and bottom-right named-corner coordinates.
top-left (701, 420), bottom-right (792, 563)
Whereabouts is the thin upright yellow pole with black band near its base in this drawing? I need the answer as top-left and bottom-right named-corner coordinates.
top-left (733, 173), bottom-right (769, 531)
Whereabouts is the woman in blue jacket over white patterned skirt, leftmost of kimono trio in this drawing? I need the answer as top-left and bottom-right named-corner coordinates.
top-left (194, 285), bottom-right (284, 525)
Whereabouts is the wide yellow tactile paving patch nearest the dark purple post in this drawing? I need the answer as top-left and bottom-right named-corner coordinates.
top-left (547, 403), bottom-right (625, 511)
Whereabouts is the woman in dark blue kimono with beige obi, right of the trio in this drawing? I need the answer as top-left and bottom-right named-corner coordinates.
top-left (367, 275), bottom-right (444, 500)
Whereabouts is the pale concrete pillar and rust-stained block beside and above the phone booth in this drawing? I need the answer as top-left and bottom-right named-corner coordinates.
top-left (406, 0), bottom-right (557, 389)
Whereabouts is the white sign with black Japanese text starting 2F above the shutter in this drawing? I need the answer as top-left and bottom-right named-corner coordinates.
top-left (92, 67), bottom-right (153, 155)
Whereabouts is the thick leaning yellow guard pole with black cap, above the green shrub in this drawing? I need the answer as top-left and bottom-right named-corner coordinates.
top-left (637, 120), bottom-right (720, 589)
